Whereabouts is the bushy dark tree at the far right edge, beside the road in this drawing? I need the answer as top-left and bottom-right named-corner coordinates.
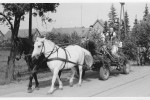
top-left (131, 14), bottom-right (150, 63)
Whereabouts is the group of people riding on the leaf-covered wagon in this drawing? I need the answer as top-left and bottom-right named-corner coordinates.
top-left (86, 26), bottom-right (122, 58)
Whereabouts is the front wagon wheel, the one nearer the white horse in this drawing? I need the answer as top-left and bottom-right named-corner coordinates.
top-left (99, 65), bottom-right (110, 80)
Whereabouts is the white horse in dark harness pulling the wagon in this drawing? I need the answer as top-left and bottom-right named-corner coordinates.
top-left (32, 37), bottom-right (93, 93)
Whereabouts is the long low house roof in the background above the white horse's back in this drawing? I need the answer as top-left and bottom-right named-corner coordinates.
top-left (52, 27), bottom-right (89, 36)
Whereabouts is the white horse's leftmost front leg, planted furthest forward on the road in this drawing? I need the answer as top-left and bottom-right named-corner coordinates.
top-left (48, 69), bottom-right (59, 94)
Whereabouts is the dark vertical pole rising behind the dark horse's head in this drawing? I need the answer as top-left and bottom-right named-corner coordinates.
top-left (29, 3), bottom-right (32, 40)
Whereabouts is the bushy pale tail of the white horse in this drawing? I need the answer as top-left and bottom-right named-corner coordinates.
top-left (82, 48), bottom-right (93, 68)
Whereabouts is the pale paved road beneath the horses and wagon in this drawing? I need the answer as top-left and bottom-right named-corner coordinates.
top-left (0, 66), bottom-right (150, 97)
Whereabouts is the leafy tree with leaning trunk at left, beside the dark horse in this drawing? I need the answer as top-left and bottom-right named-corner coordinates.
top-left (0, 3), bottom-right (59, 83)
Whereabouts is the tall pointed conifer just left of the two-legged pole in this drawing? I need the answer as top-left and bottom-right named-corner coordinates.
top-left (108, 4), bottom-right (117, 27)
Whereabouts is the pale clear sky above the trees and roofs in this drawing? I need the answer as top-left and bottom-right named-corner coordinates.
top-left (0, 0), bottom-right (150, 34)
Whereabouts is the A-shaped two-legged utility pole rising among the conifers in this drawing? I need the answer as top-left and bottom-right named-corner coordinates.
top-left (119, 2), bottom-right (127, 40)
